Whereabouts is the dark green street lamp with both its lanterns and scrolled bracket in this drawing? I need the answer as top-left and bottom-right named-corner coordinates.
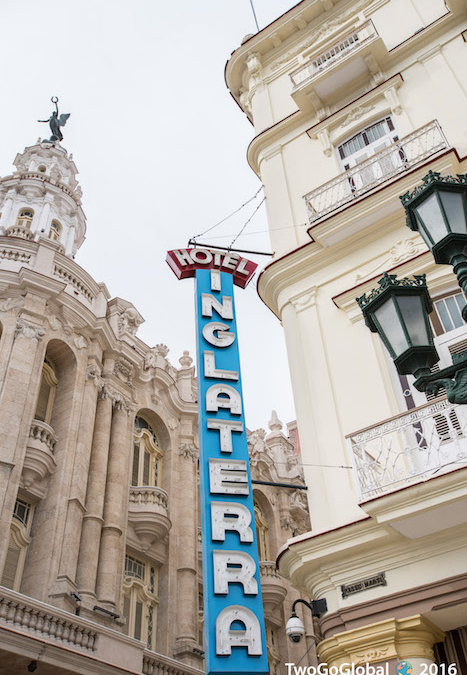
top-left (356, 171), bottom-right (467, 403)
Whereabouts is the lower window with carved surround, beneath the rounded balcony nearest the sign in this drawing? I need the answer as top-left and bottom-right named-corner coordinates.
top-left (123, 553), bottom-right (159, 650)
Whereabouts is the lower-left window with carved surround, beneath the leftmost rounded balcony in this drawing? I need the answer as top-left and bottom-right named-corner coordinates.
top-left (0, 498), bottom-right (34, 591)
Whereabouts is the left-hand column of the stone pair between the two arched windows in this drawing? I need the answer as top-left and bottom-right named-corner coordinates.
top-left (76, 385), bottom-right (112, 597)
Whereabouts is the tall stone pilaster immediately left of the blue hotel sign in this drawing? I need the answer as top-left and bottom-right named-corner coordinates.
top-left (174, 444), bottom-right (202, 668)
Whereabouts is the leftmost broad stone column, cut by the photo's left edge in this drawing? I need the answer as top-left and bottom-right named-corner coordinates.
top-left (0, 315), bottom-right (45, 571)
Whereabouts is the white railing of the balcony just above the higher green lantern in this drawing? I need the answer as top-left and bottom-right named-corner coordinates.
top-left (304, 120), bottom-right (448, 223)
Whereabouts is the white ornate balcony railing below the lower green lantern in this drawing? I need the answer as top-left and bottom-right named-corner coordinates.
top-left (347, 398), bottom-right (467, 501)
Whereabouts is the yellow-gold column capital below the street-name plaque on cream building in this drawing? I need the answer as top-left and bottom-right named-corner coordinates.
top-left (317, 614), bottom-right (444, 672)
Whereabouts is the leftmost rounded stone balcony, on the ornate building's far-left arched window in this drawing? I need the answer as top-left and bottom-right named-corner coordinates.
top-left (22, 420), bottom-right (57, 498)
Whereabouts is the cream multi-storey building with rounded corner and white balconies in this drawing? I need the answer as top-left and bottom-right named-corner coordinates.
top-left (226, 0), bottom-right (467, 674)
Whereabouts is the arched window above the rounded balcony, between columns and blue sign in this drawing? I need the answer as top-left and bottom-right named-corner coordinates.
top-left (131, 417), bottom-right (163, 487)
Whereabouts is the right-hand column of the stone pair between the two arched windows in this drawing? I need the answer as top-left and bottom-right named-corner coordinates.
top-left (96, 400), bottom-right (131, 611)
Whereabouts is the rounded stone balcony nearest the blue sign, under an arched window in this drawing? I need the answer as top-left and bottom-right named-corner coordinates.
top-left (128, 485), bottom-right (172, 551)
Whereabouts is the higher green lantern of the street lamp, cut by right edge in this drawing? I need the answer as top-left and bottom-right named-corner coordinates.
top-left (400, 171), bottom-right (467, 321)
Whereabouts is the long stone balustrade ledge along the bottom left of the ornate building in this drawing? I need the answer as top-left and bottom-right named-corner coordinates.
top-left (0, 587), bottom-right (203, 675)
